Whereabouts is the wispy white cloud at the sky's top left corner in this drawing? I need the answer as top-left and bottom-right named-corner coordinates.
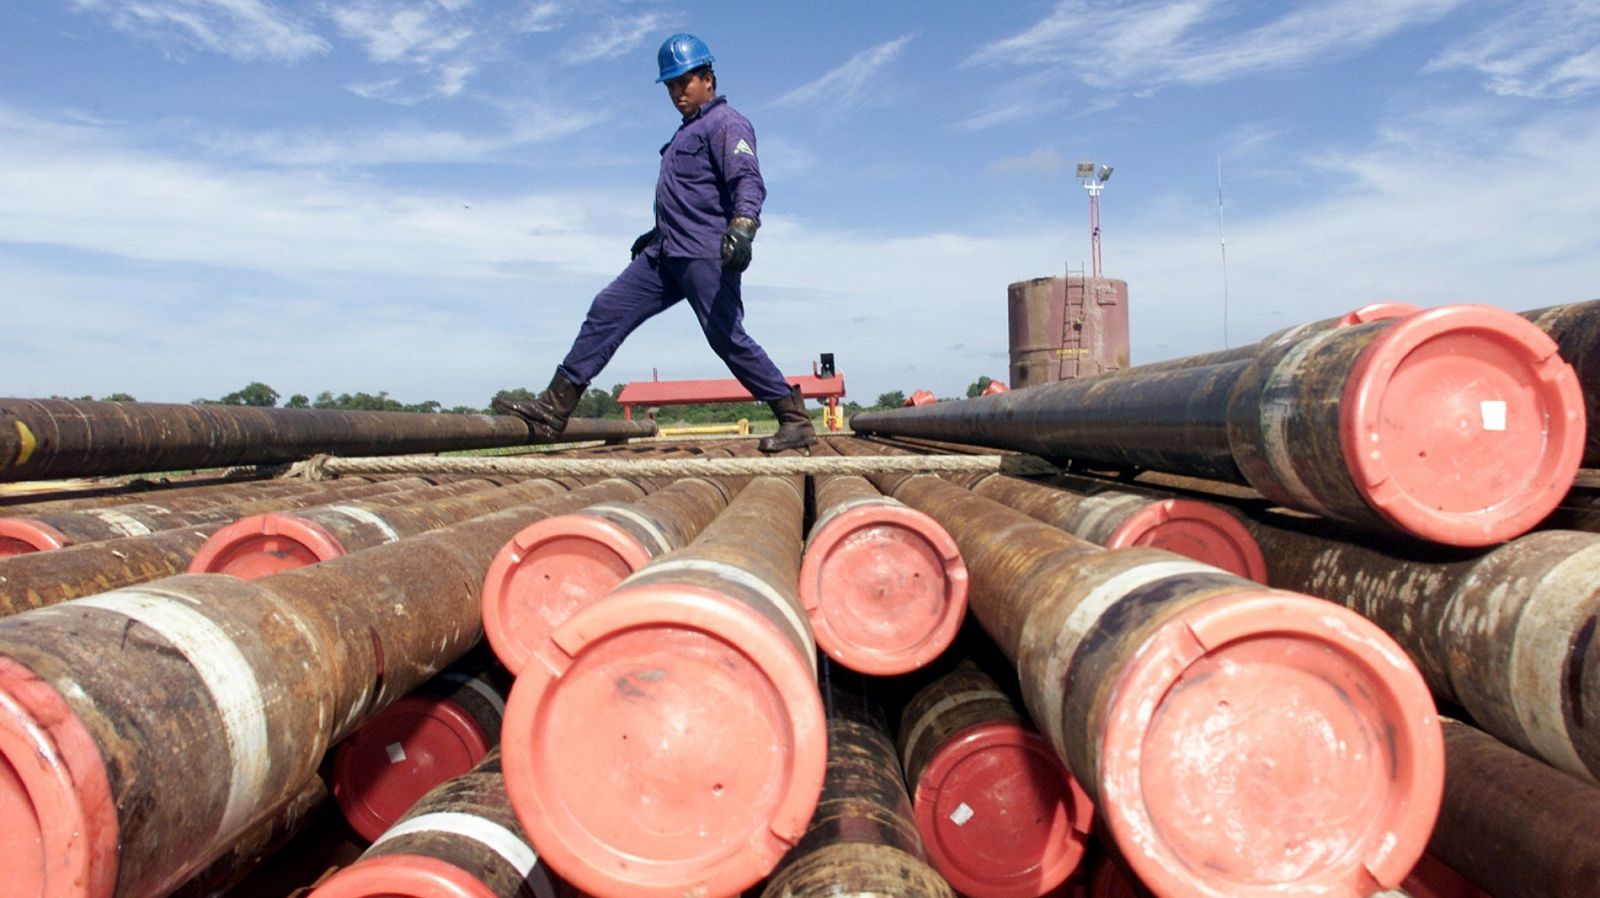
top-left (72, 0), bottom-right (328, 62)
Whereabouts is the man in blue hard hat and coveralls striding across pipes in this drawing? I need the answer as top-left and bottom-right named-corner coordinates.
top-left (491, 34), bottom-right (816, 451)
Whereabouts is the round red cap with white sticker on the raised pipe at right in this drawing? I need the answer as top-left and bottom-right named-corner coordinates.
top-left (1339, 306), bottom-right (1586, 546)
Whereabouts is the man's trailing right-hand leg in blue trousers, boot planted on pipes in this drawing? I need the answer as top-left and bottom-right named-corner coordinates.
top-left (669, 259), bottom-right (816, 451)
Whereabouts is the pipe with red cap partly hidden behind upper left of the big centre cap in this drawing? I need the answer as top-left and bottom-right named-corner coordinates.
top-left (483, 477), bottom-right (742, 674)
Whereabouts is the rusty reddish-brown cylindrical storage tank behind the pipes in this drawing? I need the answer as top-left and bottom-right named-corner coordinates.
top-left (1006, 275), bottom-right (1128, 389)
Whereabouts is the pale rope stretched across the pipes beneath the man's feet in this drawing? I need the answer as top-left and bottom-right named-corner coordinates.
top-left (290, 455), bottom-right (1059, 480)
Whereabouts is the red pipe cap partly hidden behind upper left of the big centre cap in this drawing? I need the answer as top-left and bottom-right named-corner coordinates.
top-left (483, 512), bottom-right (651, 674)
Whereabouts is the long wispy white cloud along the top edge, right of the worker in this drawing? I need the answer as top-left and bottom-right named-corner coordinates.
top-left (966, 0), bottom-right (1462, 90)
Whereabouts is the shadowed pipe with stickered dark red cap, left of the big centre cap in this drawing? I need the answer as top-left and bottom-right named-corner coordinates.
top-left (328, 643), bottom-right (510, 842)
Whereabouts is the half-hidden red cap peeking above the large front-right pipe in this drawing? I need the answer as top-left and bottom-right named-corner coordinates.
top-left (1106, 499), bottom-right (1267, 583)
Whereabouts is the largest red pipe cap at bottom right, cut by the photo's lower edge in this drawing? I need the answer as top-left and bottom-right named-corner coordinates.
top-left (1098, 589), bottom-right (1445, 898)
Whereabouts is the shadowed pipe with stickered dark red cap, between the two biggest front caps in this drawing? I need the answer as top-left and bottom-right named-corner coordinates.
top-left (899, 661), bottom-right (1094, 898)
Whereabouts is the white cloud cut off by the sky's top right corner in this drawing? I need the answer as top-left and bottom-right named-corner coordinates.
top-left (1429, 0), bottom-right (1600, 99)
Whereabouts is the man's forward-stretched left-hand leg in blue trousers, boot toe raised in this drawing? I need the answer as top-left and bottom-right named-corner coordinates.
top-left (490, 251), bottom-right (680, 440)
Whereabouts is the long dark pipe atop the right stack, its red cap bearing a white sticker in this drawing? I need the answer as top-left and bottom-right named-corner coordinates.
top-left (851, 306), bottom-right (1584, 546)
